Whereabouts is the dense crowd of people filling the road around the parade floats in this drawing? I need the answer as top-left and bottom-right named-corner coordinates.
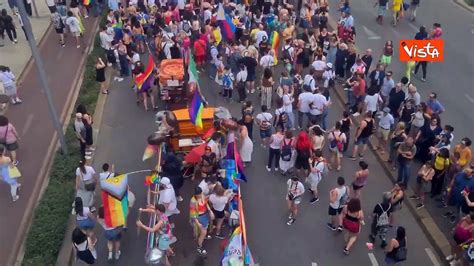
top-left (11, 0), bottom-right (466, 264)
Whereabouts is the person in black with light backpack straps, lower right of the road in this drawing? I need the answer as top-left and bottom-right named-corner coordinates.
top-left (369, 192), bottom-right (392, 248)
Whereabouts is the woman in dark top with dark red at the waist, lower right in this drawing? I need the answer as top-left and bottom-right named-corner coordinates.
top-left (342, 198), bottom-right (365, 255)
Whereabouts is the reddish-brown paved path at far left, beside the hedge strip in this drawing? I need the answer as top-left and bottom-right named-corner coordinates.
top-left (0, 17), bottom-right (96, 265)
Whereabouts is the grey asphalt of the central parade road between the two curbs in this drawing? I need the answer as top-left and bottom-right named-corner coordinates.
top-left (83, 57), bottom-right (442, 266)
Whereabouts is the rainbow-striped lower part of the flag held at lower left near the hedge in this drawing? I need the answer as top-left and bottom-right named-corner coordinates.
top-left (102, 191), bottom-right (128, 228)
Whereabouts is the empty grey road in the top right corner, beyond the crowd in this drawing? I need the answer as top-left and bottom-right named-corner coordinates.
top-left (330, 0), bottom-right (474, 142)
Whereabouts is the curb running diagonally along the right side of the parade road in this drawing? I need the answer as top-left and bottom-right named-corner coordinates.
top-left (328, 16), bottom-right (450, 262)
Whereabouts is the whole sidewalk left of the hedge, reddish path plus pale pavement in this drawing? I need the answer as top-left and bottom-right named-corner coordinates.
top-left (0, 10), bottom-right (98, 266)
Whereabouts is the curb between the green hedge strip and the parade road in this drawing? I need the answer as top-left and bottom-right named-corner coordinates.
top-left (56, 61), bottom-right (114, 266)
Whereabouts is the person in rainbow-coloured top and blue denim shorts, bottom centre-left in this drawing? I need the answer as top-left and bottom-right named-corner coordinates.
top-left (189, 187), bottom-right (214, 256)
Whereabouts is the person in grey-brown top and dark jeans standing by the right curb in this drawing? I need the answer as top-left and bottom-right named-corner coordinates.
top-left (397, 137), bottom-right (416, 187)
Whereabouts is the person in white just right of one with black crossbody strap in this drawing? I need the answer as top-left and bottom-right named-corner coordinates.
top-left (306, 149), bottom-right (326, 204)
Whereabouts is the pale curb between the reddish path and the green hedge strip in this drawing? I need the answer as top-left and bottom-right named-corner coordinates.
top-left (7, 17), bottom-right (99, 265)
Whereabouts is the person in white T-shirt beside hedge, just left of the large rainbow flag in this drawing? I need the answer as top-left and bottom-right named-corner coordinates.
top-left (76, 161), bottom-right (96, 207)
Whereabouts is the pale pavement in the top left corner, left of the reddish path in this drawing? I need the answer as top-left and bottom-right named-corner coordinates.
top-left (0, 0), bottom-right (50, 79)
